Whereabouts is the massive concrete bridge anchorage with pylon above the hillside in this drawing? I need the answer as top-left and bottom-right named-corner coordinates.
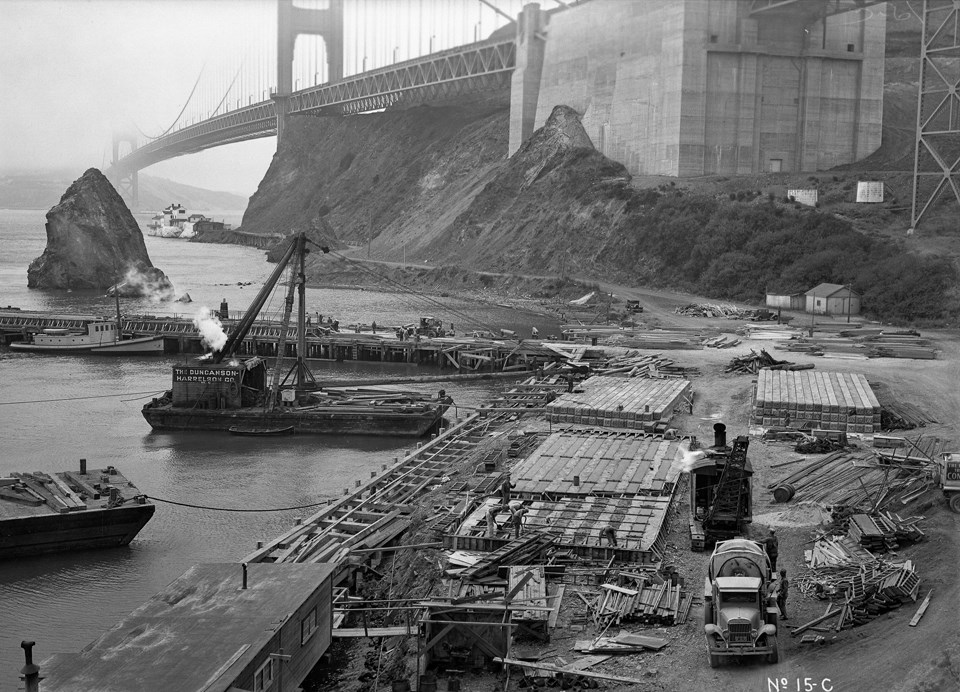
top-left (510, 0), bottom-right (886, 176)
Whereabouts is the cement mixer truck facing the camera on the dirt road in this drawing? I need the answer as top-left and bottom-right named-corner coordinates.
top-left (703, 538), bottom-right (780, 668)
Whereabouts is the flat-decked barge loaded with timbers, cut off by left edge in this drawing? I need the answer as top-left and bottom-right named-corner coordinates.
top-left (0, 459), bottom-right (156, 559)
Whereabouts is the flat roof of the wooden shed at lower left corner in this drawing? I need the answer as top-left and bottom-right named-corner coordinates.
top-left (40, 563), bottom-right (333, 692)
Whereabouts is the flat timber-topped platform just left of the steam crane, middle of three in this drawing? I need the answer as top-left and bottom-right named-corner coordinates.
top-left (510, 429), bottom-right (683, 497)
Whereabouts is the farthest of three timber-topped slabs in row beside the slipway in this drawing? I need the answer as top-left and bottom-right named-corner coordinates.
top-left (546, 375), bottom-right (693, 432)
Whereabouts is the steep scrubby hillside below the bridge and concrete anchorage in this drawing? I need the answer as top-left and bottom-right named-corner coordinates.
top-left (232, 2), bottom-right (960, 321)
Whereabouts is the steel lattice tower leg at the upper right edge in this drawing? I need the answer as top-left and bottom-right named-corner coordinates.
top-left (909, 0), bottom-right (960, 232)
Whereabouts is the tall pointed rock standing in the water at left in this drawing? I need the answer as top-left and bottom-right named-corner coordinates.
top-left (27, 168), bottom-right (173, 299)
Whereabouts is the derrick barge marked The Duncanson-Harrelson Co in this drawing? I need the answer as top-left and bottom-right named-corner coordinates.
top-left (143, 233), bottom-right (453, 437)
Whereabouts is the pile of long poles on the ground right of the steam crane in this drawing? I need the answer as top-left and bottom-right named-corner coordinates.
top-left (767, 451), bottom-right (931, 508)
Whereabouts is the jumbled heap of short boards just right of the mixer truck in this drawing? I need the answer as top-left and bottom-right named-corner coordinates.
top-left (791, 560), bottom-right (920, 636)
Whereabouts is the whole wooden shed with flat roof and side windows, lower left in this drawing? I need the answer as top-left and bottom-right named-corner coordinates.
top-left (40, 563), bottom-right (333, 692)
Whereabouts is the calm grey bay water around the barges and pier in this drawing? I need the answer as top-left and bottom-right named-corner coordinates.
top-left (0, 209), bottom-right (558, 692)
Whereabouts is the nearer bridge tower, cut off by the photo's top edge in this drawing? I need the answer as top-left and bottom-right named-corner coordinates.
top-left (272, 0), bottom-right (343, 146)
